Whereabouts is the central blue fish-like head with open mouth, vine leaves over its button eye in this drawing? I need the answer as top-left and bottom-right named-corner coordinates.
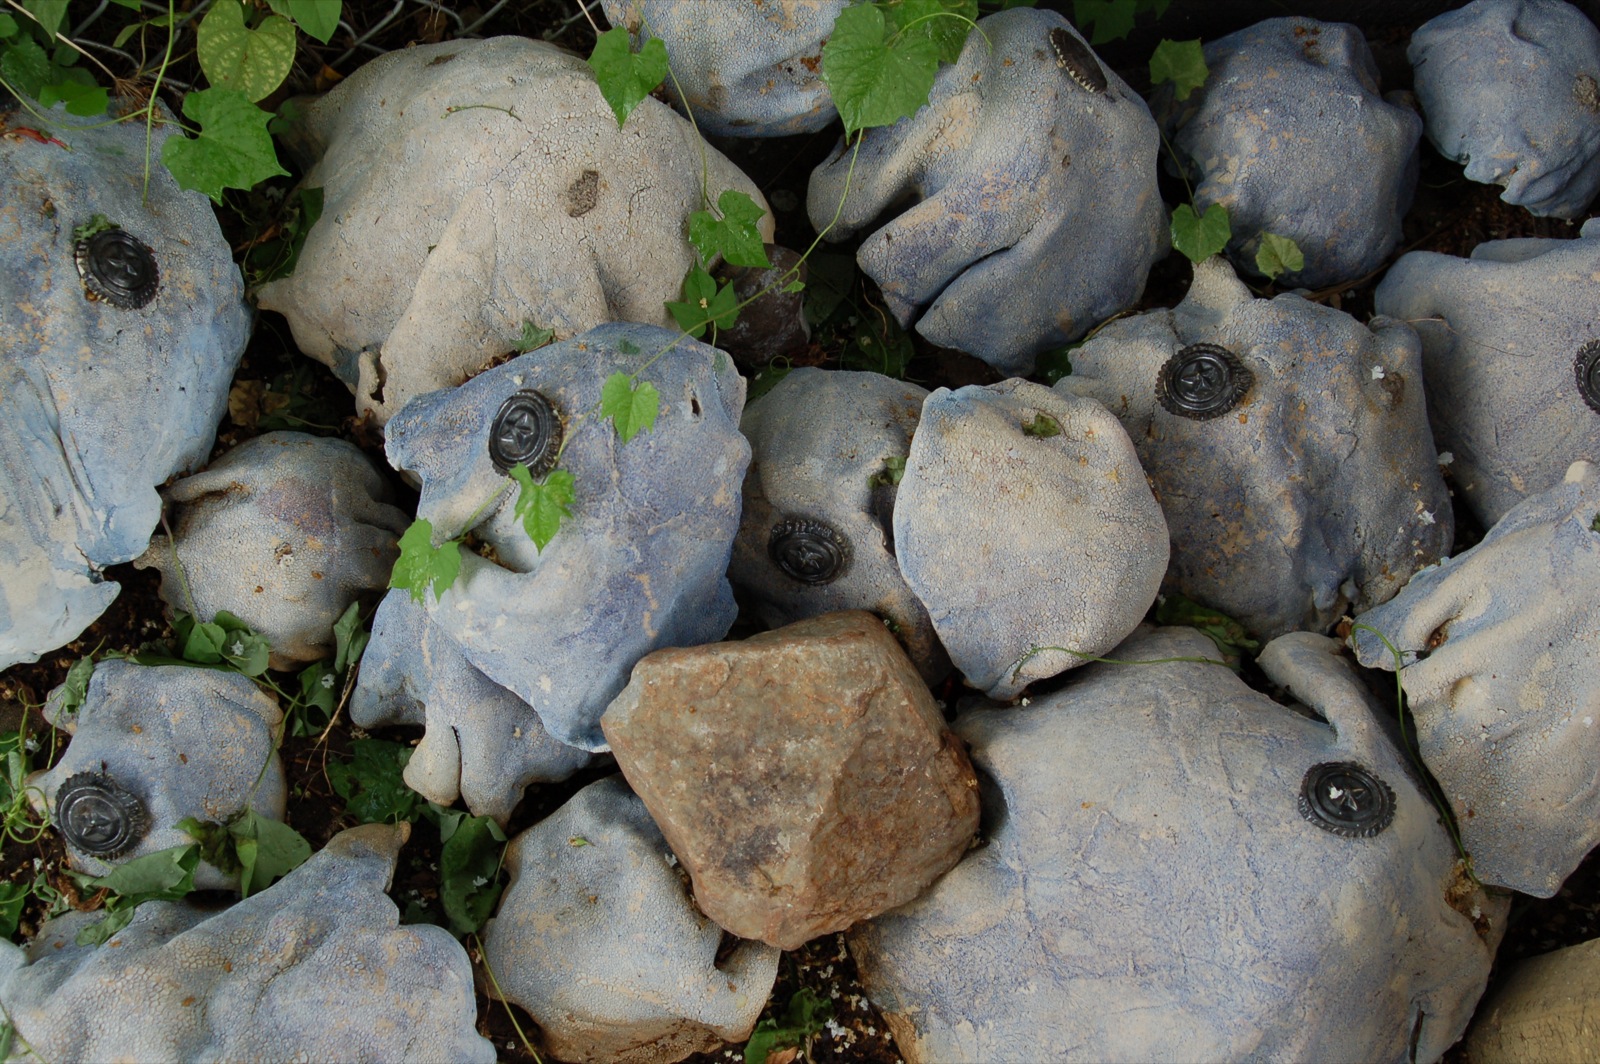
top-left (355, 325), bottom-right (750, 750)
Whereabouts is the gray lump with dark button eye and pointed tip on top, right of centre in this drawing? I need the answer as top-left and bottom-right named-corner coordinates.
top-left (1056, 258), bottom-right (1454, 640)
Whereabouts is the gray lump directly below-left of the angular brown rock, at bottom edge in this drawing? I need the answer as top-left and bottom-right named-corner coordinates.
top-left (483, 776), bottom-right (778, 1064)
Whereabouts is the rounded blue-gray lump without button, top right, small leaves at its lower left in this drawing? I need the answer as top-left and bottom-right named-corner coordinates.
top-left (1155, 18), bottom-right (1422, 288)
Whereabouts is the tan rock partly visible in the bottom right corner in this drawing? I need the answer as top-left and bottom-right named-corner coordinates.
top-left (1466, 939), bottom-right (1600, 1064)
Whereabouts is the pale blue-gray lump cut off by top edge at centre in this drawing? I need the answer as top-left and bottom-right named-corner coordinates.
top-left (600, 0), bottom-right (848, 136)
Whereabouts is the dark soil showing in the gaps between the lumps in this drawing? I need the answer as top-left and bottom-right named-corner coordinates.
top-left (0, 0), bottom-right (1600, 1064)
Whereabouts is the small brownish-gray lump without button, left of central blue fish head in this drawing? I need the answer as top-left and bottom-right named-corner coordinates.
top-left (134, 432), bottom-right (411, 669)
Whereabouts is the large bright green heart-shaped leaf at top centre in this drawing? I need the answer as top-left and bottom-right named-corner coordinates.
top-left (822, 5), bottom-right (939, 138)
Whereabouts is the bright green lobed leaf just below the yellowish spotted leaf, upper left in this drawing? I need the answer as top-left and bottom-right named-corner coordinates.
top-left (162, 87), bottom-right (288, 206)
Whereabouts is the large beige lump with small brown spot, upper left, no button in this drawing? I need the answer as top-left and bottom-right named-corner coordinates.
top-left (261, 37), bottom-right (771, 422)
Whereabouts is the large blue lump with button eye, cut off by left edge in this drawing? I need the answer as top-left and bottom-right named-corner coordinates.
top-left (0, 94), bottom-right (250, 669)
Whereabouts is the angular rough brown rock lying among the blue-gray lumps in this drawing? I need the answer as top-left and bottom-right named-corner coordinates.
top-left (600, 610), bottom-right (978, 949)
